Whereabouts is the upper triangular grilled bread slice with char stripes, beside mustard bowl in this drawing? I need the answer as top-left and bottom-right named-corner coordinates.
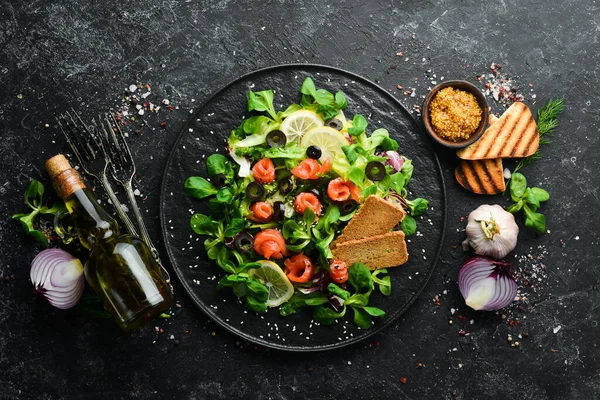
top-left (456, 102), bottom-right (540, 160)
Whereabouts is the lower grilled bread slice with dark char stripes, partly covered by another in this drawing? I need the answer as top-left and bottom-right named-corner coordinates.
top-left (454, 114), bottom-right (506, 194)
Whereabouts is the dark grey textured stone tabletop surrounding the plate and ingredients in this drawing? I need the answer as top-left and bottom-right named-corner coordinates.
top-left (0, 0), bottom-right (600, 399)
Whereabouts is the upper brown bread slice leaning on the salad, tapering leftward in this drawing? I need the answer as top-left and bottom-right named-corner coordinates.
top-left (331, 195), bottom-right (405, 248)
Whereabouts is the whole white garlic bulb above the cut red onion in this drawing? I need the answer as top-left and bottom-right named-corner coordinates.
top-left (465, 204), bottom-right (519, 260)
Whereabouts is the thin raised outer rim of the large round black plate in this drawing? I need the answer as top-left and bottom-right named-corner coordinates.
top-left (159, 63), bottom-right (447, 353)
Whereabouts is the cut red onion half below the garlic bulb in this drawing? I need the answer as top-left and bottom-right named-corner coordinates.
top-left (458, 257), bottom-right (517, 311)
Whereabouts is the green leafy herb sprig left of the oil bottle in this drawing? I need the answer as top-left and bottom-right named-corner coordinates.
top-left (12, 179), bottom-right (65, 247)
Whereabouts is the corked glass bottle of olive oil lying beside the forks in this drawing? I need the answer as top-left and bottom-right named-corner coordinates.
top-left (46, 154), bottom-right (172, 331)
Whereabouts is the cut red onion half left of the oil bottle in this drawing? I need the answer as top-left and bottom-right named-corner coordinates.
top-left (30, 249), bottom-right (84, 309)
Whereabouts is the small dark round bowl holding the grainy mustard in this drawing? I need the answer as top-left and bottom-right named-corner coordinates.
top-left (422, 81), bottom-right (488, 150)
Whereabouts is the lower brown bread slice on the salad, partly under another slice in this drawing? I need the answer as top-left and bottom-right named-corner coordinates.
top-left (332, 231), bottom-right (408, 271)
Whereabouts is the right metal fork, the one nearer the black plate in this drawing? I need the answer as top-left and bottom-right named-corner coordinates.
top-left (98, 113), bottom-right (171, 283)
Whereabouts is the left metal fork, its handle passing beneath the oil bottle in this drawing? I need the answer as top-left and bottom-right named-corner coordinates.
top-left (56, 110), bottom-right (138, 236)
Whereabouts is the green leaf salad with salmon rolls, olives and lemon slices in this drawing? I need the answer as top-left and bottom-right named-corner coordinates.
top-left (185, 78), bottom-right (428, 329)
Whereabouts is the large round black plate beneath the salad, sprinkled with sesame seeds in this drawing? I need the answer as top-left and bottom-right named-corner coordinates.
top-left (160, 64), bottom-right (446, 351)
